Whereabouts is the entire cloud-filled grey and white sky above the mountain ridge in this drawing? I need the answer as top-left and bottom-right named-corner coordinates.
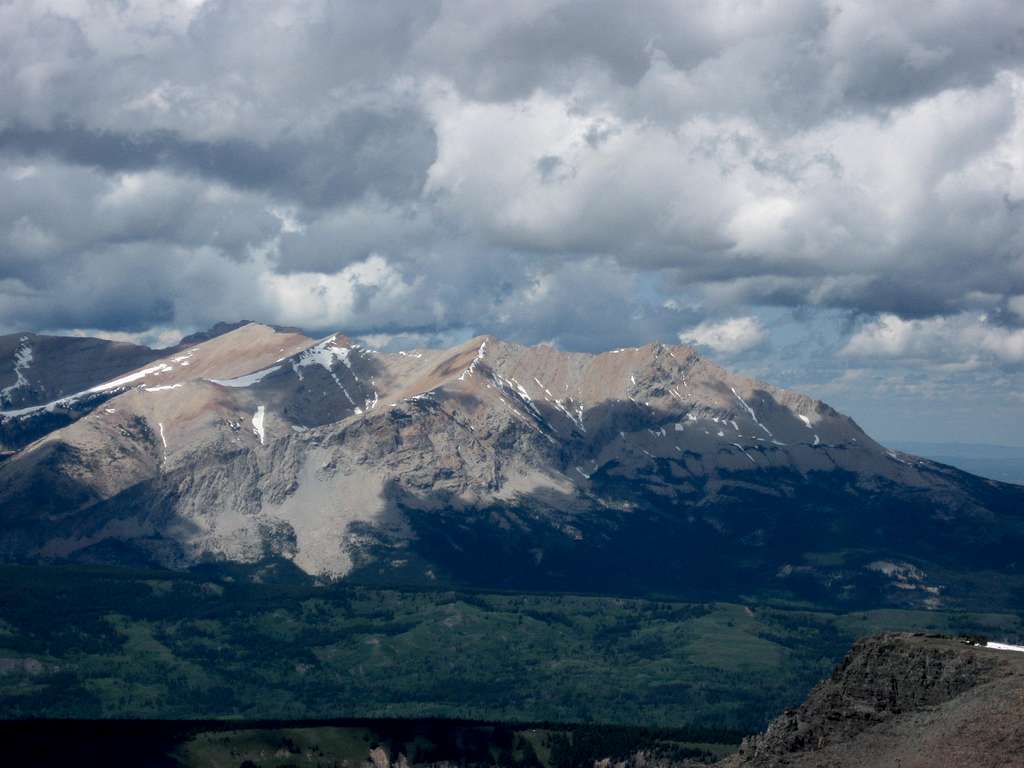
top-left (0, 0), bottom-right (1024, 445)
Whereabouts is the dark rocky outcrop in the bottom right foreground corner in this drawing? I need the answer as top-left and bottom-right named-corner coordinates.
top-left (721, 634), bottom-right (1024, 768)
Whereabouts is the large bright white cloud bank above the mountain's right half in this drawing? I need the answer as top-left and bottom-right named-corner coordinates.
top-left (413, 66), bottom-right (1024, 315)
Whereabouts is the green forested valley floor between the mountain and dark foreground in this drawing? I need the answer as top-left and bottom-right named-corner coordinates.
top-left (0, 566), bottom-right (1024, 729)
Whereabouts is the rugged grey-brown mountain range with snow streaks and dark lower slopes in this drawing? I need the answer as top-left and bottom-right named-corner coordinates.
top-left (0, 324), bottom-right (1024, 607)
